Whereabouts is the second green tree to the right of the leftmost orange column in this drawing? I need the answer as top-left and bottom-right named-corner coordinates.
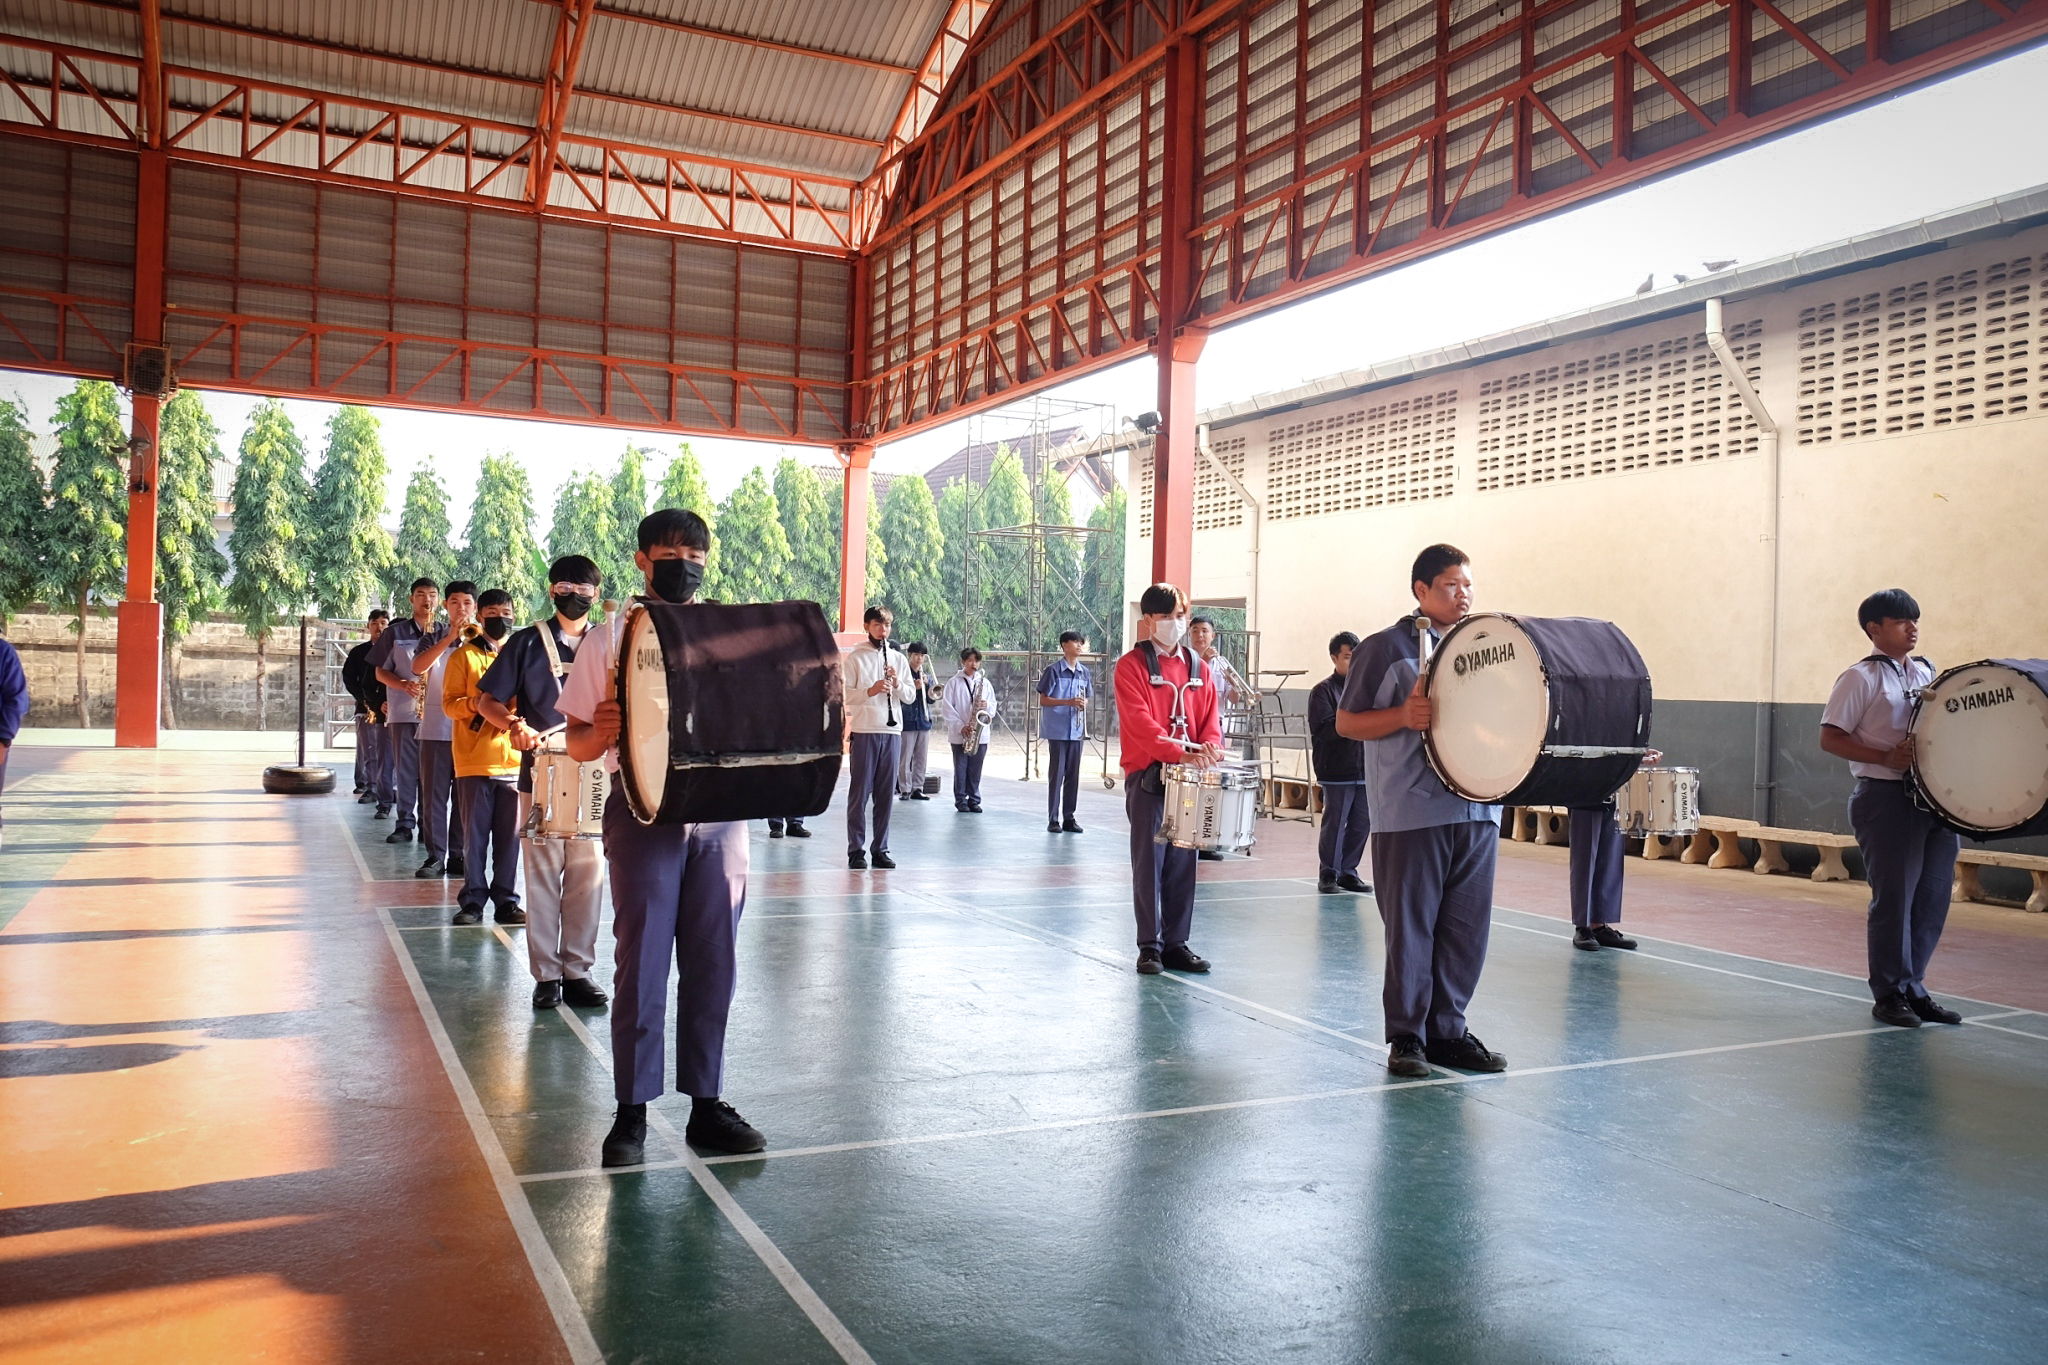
top-left (227, 399), bottom-right (313, 731)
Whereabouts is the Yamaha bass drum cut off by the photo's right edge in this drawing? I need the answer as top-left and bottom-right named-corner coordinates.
top-left (1907, 659), bottom-right (2048, 839)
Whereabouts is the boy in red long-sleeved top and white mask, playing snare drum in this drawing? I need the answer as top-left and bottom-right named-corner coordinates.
top-left (1116, 583), bottom-right (1223, 976)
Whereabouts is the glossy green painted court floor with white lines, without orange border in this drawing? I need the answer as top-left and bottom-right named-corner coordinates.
top-left (380, 788), bottom-right (2048, 1363)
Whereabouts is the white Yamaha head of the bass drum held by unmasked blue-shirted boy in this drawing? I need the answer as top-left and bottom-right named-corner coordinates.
top-left (1425, 614), bottom-right (1550, 802)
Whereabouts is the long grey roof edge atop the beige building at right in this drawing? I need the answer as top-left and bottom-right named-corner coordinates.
top-left (1196, 184), bottom-right (2048, 426)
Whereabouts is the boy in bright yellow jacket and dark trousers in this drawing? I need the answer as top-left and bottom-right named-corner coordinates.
top-left (440, 587), bottom-right (526, 925)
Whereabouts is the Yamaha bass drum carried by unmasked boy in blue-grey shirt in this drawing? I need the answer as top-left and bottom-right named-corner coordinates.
top-left (1423, 612), bottom-right (1651, 806)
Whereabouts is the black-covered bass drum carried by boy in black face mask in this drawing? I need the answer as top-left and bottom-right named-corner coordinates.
top-left (616, 602), bottom-right (844, 825)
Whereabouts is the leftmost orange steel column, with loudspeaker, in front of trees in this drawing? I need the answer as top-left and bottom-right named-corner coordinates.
top-left (115, 149), bottom-right (170, 749)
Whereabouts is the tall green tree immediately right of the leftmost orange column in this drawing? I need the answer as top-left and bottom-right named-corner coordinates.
top-left (156, 389), bottom-right (227, 729)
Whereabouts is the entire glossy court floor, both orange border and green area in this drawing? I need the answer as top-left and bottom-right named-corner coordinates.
top-left (0, 747), bottom-right (2048, 1363)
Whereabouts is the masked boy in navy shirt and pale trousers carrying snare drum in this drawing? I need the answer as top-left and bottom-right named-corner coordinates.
top-left (477, 555), bottom-right (608, 1009)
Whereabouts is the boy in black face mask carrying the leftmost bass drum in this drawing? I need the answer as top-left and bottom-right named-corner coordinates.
top-left (555, 508), bottom-right (766, 1166)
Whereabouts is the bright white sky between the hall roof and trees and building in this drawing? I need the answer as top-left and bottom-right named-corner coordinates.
top-left (0, 47), bottom-right (2048, 534)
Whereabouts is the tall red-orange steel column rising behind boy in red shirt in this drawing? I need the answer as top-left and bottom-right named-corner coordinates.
top-left (1153, 39), bottom-right (1208, 593)
